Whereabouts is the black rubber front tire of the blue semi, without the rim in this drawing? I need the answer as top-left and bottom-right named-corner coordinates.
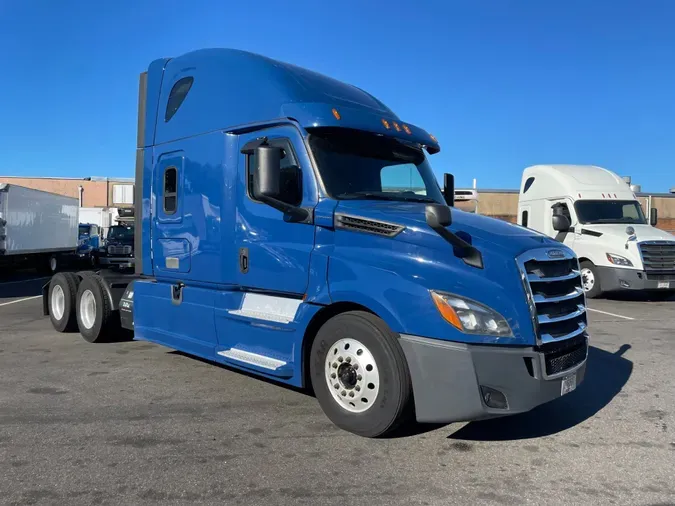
top-left (309, 311), bottom-right (414, 437)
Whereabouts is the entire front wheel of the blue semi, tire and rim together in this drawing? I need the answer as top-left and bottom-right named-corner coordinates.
top-left (310, 311), bottom-right (413, 437)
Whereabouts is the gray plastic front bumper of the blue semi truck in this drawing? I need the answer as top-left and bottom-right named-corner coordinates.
top-left (401, 335), bottom-right (588, 423)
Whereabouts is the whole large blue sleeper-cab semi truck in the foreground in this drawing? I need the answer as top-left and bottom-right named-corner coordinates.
top-left (43, 49), bottom-right (588, 437)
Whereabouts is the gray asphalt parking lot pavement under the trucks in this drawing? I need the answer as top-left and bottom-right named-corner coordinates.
top-left (0, 278), bottom-right (675, 506)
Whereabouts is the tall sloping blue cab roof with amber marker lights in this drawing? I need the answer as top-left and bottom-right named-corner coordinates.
top-left (142, 48), bottom-right (440, 153)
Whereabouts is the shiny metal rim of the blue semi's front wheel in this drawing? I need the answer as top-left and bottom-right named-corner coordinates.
top-left (324, 338), bottom-right (380, 413)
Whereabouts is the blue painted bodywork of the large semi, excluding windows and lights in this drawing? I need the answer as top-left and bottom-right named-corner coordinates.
top-left (134, 50), bottom-right (572, 385)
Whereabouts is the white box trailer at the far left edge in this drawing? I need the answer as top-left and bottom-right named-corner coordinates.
top-left (0, 183), bottom-right (79, 272)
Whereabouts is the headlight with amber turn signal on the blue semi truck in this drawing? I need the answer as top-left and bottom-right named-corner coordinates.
top-left (431, 290), bottom-right (513, 337)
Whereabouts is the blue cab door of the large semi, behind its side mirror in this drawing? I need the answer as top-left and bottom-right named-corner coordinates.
top-left (235, 125), bottom-right (317, 295)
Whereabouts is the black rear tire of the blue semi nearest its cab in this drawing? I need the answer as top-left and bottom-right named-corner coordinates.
top-left (76, 274), bottom-right (120, 343)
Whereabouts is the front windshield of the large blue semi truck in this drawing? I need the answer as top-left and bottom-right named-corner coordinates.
top-left (309, 128), bottom-right (445, 204)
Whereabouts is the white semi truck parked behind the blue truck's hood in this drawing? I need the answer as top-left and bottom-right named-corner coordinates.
top-left (518, 165), bottom-right (675, 298)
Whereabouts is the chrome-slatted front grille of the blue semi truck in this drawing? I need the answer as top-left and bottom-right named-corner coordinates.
top-left (517, 248), bottom-right (588, 345)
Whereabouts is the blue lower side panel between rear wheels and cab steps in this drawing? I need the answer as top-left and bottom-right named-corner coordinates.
top-left (134, 280), bottom-right (218, 360)
